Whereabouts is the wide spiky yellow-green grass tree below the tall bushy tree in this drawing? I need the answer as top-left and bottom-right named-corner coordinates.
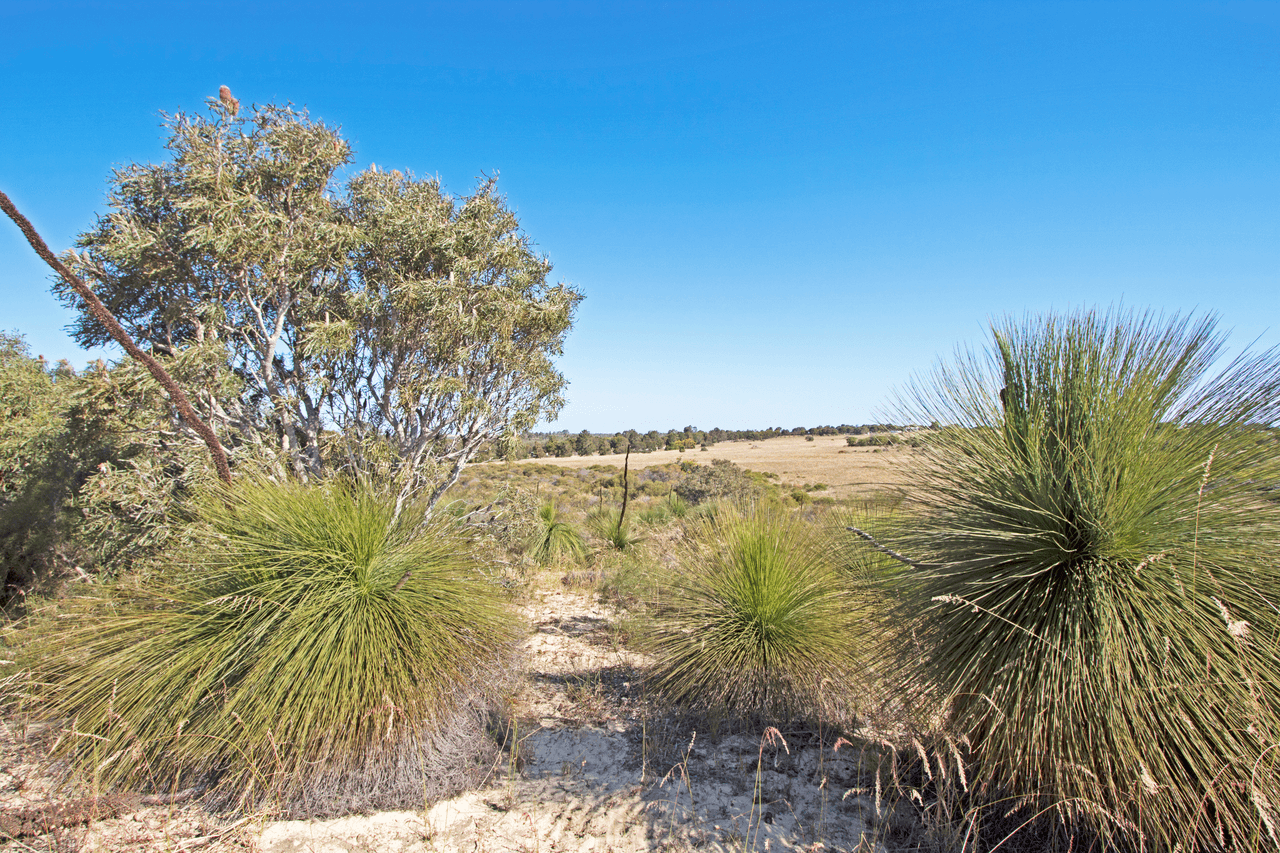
top-left (24, 483), bottom-right (515, 815)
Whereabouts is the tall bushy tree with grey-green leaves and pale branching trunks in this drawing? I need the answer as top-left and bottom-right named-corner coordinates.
top-left (54, 99), bottom-right (581, 507)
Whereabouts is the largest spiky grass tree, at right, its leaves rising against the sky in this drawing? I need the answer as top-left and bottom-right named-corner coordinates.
top-left (895, 311), bottom-right (1280, 850)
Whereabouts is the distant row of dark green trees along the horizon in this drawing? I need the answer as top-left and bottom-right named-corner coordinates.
top-left (494, 424), bottom-right (911, 459)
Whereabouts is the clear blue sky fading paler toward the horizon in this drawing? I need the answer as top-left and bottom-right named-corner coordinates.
top-left (0, 0), bottom-right (1280, 432)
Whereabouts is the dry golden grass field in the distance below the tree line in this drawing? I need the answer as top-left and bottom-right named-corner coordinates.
top-left (496, 435), bottom-right (911, 498)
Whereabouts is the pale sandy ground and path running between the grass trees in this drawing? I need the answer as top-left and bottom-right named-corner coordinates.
top-left (0, 589), bottom-right (918, 853)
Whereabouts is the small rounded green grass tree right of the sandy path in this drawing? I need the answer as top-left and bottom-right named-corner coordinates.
top-left (648, 507), bottom-right (863, 721)
